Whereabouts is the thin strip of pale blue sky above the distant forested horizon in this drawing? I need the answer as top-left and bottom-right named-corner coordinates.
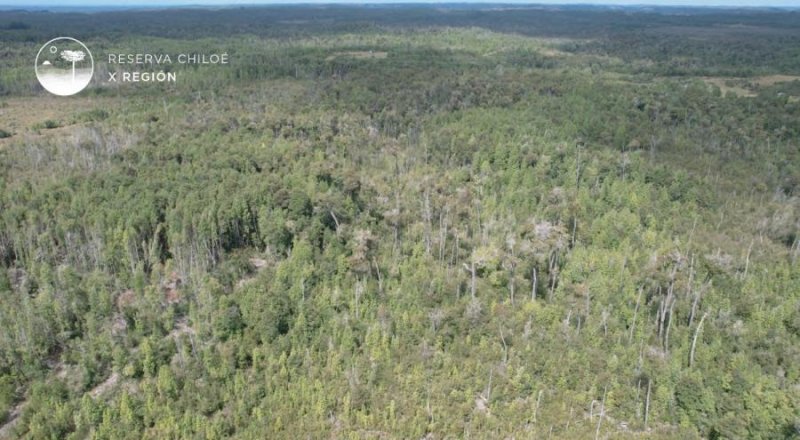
top-left (0, 0), bottom-right (800, 8)
